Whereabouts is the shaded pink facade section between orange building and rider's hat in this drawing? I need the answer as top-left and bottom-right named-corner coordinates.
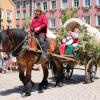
top-left (13, 0), bottom-right (34, 28)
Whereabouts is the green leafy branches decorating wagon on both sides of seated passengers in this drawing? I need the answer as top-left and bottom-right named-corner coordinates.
top-left (56, 25), bottom-right (100, 65)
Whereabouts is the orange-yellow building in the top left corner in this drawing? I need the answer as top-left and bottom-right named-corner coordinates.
top-left (0, 0), bottom-right (16, 29)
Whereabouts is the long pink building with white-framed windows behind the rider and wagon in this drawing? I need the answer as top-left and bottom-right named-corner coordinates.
top-left (12, 0), bottom-right (100, 32)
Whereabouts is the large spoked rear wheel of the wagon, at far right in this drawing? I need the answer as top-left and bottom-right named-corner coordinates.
top-left (85, 59), bottom-right (97, 83)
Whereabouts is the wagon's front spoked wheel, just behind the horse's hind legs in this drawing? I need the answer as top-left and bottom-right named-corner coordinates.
top-left (63, 63), bottom-right (73, 80)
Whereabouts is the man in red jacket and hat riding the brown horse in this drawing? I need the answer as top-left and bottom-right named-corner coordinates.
top-left (29, 6), bottom-right (48, 58)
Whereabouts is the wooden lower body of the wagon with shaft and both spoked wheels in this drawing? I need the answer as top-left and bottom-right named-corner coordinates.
top-left (49, 48), bottom-right (97, 83)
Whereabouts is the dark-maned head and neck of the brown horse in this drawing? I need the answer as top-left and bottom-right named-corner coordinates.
top-left (0, 28), bottom-right (27, 56)
